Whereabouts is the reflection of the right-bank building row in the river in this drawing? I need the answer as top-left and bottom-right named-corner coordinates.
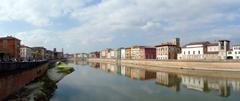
top-left (90, 63), bottom-right (240, 97)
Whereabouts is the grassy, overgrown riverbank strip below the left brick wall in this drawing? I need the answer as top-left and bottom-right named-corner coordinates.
top-left (6, 62), bottom-right (74, 101)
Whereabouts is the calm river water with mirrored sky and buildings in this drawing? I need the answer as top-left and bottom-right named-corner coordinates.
top-left (51, 63), bottom-right (240, 101)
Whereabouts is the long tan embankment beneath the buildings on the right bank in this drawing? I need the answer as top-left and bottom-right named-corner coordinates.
top-left (88, 59), bottom-right (240, 71)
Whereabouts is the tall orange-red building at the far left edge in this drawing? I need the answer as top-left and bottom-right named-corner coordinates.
top-left (0, 36), bottom-right (21, 61)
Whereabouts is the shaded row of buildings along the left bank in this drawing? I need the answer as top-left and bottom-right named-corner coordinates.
top-left (0, 36), bottom-right (63, 62)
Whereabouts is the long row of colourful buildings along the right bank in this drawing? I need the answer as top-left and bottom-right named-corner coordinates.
top-left (89, 38), bottom-right (240, 60)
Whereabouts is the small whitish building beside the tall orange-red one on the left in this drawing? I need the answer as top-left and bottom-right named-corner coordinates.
top-left (20, 45), bottom-right (33, 61)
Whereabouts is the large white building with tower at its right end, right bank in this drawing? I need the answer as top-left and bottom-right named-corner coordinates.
top-left (178, 40), bottom-right (230, 60)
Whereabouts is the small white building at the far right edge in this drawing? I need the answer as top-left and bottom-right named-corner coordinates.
top-left (227, 44), bottom-right (240, 60)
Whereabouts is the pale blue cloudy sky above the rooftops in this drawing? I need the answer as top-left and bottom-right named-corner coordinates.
top-left (0, 0), bottom-right (240, 53)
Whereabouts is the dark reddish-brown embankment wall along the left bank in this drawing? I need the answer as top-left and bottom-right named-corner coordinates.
top-left (0, 63), bottom-right (49, 100)
